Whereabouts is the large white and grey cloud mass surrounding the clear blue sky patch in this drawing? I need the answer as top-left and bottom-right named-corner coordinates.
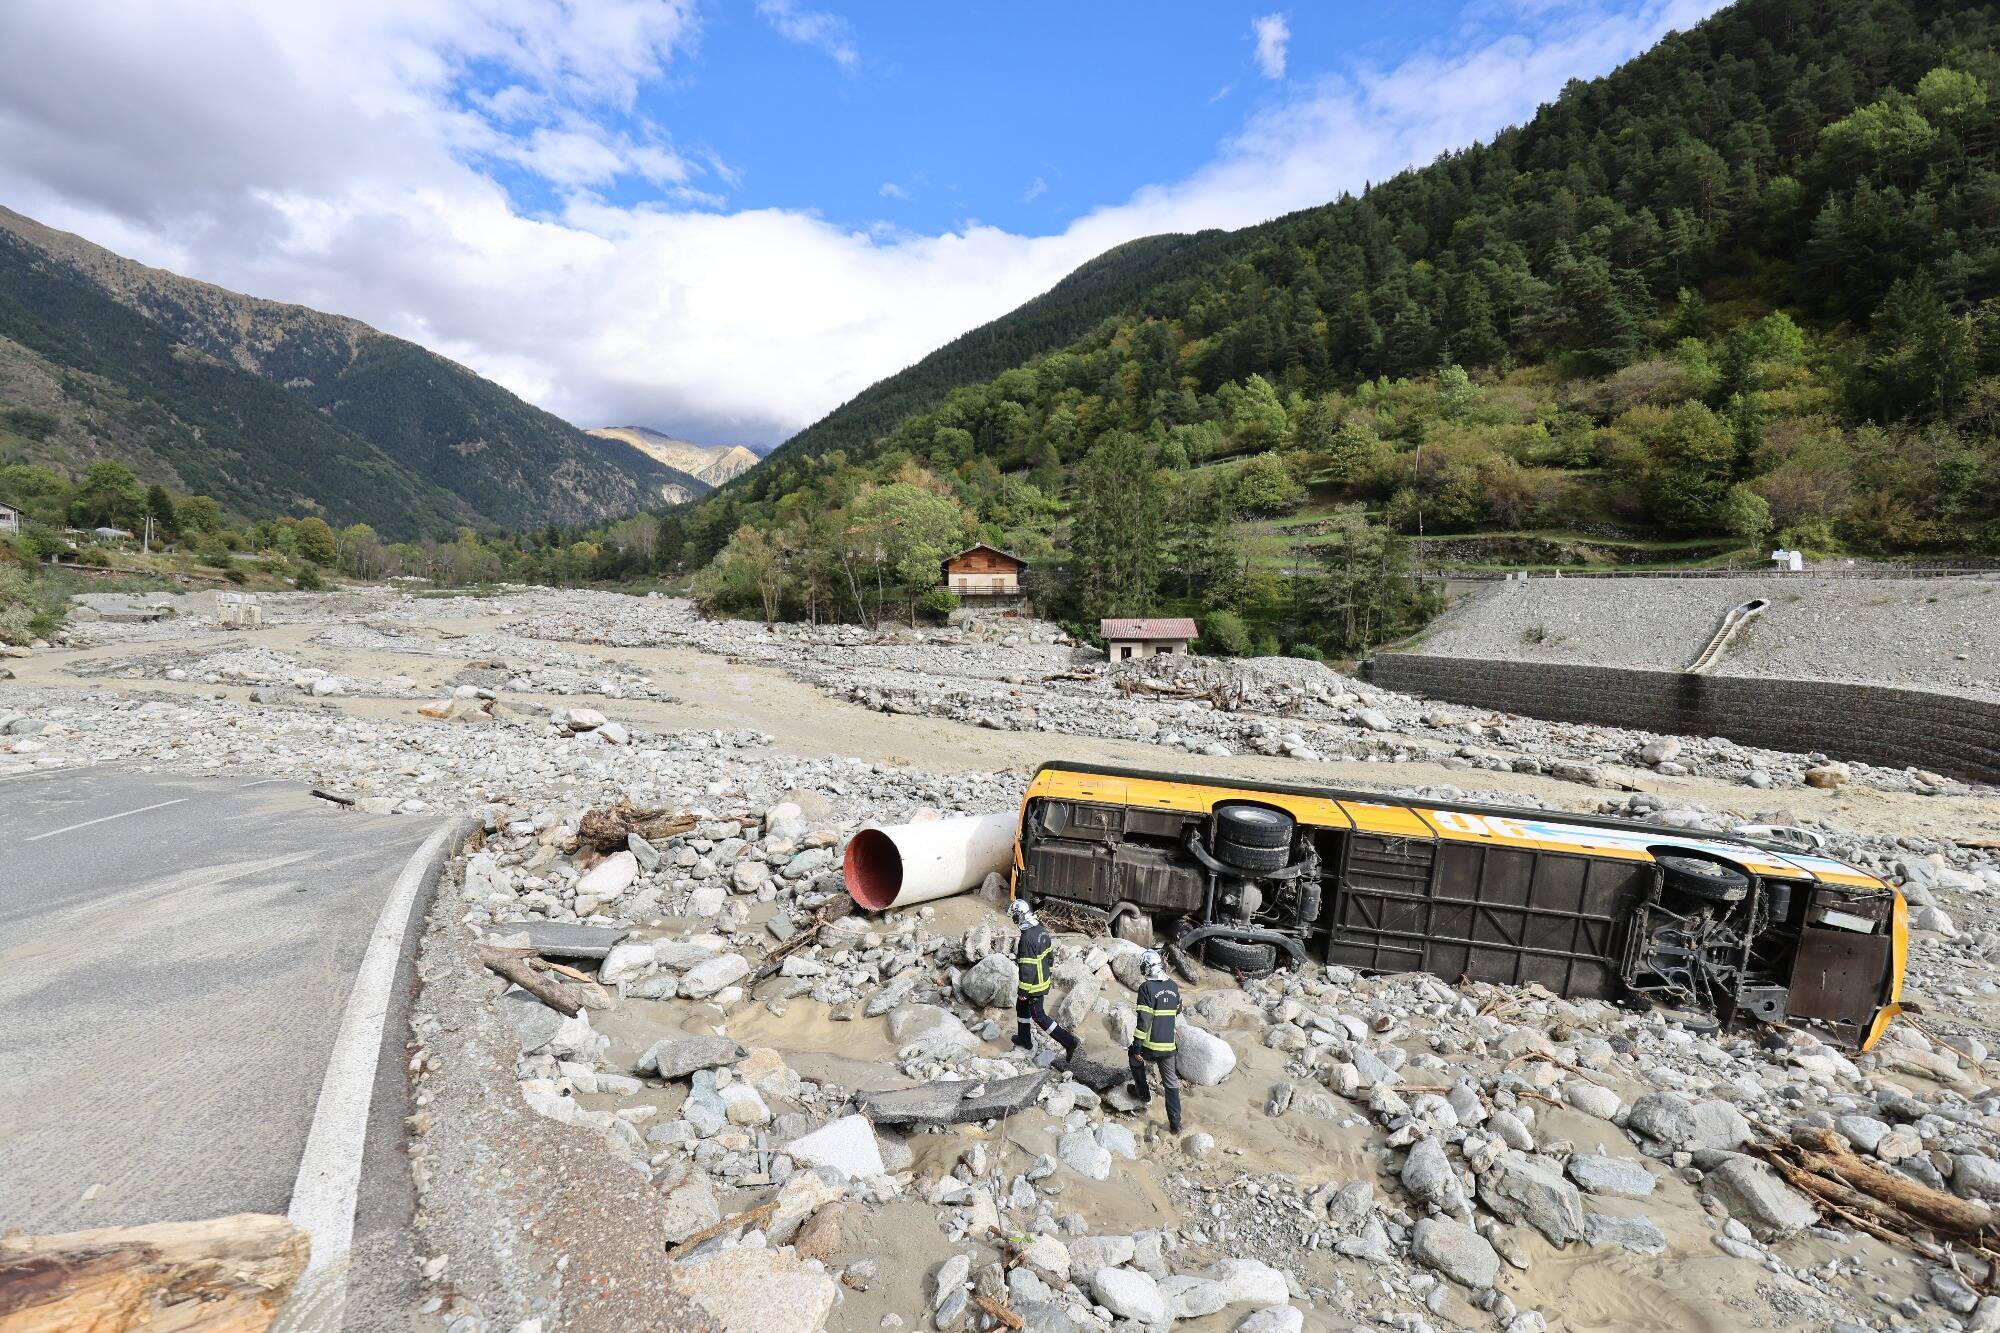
top-left (0, 0), bottom-right (1718, 442)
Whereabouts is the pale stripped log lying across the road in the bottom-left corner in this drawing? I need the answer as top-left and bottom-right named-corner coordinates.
top-left (0, 1213), bottom-right (308, 1333)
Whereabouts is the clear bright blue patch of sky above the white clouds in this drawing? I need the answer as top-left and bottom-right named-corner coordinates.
top-left (494, 0), bottom-right (1572, 232)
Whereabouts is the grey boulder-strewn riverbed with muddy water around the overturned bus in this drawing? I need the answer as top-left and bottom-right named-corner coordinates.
top-left (0, 590), bottom-right (2000, 1333)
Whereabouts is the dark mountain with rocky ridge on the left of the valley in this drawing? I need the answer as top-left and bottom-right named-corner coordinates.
top-left (0, 208), bottom-right (702, 536)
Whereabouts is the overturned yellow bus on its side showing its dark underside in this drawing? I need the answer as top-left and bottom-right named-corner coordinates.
top-left (1012, 763), bottom-right (1908, 1049)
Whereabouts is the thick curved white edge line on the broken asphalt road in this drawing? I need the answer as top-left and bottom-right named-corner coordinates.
top-left (286, 821), bottom-right (454, 1329)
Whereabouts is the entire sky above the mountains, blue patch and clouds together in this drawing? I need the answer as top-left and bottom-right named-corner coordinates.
top-left (0, 0), bottom-right (1718, 446)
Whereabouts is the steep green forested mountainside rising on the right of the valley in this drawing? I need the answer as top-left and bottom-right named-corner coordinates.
top-left (686, 0), bottom-right (2000, 642)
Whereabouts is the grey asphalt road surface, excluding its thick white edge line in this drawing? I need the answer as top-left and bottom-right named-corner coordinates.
top-left (0, 769), bottom-right (436, 1253)
